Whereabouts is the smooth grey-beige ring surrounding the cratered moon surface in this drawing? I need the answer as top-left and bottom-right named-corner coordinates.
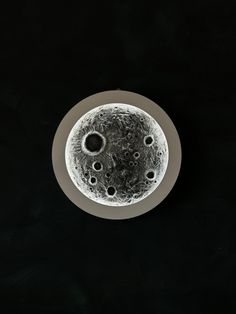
top-left (52, 90), bottom-right (182, 219)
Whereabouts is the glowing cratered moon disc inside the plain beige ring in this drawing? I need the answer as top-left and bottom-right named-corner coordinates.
top-left (65, 103), bottom-right (168, 207)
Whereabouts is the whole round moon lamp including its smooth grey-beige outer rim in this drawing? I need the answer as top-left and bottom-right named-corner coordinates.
top-left (52, 90), bottom-right (181, 219)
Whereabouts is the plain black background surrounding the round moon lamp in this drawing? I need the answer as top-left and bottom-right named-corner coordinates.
top-left (0, 0), bottom-right (236, 314)
